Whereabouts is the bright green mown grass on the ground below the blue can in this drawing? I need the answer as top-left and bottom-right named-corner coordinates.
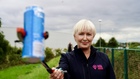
top-left (0, 57), bottom-right (60, 79)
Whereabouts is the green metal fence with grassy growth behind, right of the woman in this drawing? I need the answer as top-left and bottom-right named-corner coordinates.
top-left (98, 47), bottom-right (140, 79)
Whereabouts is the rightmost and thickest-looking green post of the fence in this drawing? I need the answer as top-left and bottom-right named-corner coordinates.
top-left (124, 49), bottom-right (128, 79)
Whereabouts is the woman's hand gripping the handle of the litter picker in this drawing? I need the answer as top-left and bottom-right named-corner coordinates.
top-left (50, 68), bottom-right (64, 79)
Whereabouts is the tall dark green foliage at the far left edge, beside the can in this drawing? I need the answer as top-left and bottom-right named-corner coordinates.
top-left (0, 19), bottom-right (21, 69)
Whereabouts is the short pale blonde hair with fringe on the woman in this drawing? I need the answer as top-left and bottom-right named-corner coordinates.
top-left (73, 19), bottom-right (96, 36)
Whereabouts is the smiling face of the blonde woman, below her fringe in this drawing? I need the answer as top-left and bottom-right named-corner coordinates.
top-left (74, 30), bottom-right (94, 49)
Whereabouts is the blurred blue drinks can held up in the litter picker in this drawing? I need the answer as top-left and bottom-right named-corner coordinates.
top-left (22, 6), bottom-right (45, 63)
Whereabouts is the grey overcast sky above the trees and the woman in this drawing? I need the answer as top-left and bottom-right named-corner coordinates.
top-left (0, 0), bottom-right (140, 48)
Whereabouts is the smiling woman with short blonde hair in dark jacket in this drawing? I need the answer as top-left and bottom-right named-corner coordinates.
top-left (50, 19), bottom-right (115, 79)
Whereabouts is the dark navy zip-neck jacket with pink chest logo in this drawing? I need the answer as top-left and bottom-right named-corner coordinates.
top-left (59, 46), bottom-right (116, 79)
